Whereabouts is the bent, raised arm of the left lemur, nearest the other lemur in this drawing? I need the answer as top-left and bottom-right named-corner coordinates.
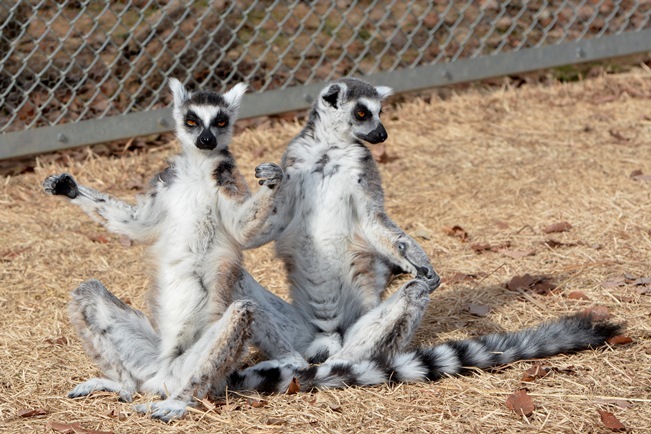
top-left (218, 163), bottom-right (283, 248)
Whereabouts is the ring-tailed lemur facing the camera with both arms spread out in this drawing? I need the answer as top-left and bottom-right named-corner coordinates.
top-left (43, 79), bottom-right (306, 420)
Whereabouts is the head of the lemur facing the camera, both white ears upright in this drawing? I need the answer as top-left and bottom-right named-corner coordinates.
top-left (169, 78), bottom-right (247, 153)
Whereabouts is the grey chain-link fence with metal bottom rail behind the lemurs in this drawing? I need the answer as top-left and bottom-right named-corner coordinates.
top-left (0, 0), bottom-right (651, 158)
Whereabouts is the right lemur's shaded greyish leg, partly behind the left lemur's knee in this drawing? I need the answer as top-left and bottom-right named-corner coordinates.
top-left (240, 271), bottom-right (314, 368)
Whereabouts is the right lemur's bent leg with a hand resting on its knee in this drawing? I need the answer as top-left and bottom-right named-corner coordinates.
top-left (328, 279), bottom-right (430, 363)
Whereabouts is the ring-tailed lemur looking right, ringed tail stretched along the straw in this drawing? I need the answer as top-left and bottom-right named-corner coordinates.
top-left (230, 78), bottom-right (619, 392)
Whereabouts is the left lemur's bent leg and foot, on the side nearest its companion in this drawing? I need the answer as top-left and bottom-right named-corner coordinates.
top-left (134, 300), bottom-right (255, 422)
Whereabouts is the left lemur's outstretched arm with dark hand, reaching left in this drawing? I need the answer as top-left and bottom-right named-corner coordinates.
top-left (43, 173), bottom-right (162, 243)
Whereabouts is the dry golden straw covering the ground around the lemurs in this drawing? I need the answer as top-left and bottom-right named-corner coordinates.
top-left (0, 70), bottom-right (651, 433)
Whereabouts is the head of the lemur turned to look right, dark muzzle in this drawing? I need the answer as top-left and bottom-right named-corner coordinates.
top-left (315, 78), bottom-right (392, 144)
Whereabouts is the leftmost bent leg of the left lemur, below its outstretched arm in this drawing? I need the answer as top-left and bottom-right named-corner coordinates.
top-left (68, 280), bottom-right (160, 402)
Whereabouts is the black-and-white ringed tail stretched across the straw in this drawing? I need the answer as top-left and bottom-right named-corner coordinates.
top-left (229, 314), bottom-right (621, 393)
